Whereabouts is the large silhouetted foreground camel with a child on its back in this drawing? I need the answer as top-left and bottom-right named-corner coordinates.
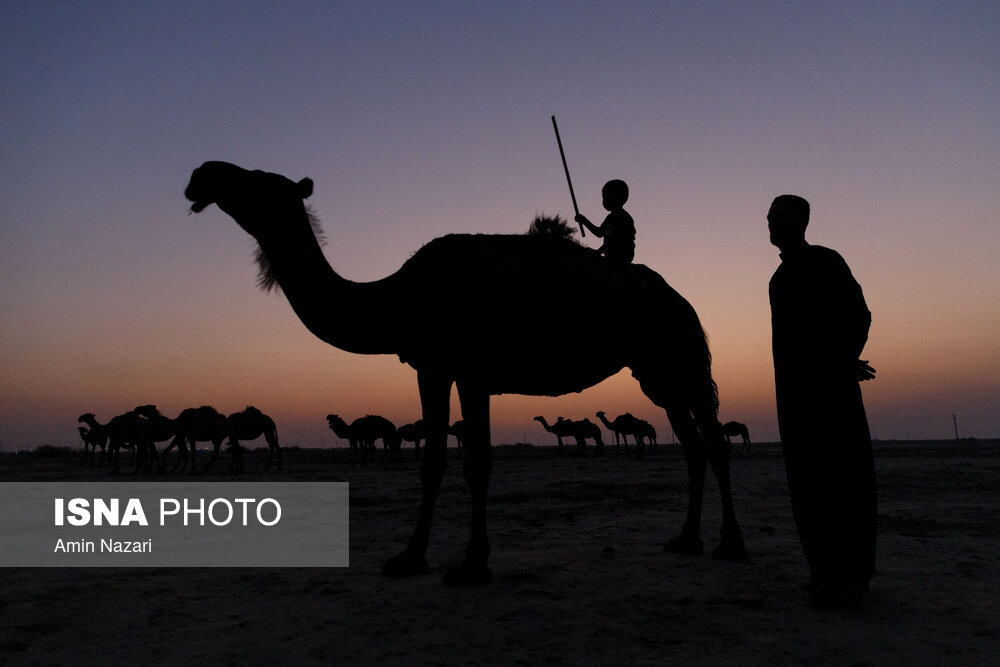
top-left (185, 162), bottom-right (746, 585)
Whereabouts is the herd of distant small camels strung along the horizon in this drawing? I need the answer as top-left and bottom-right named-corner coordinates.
top-left (77, 405), bottom-right (750, 474)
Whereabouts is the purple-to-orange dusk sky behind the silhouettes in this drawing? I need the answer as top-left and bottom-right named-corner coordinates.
top-left (0, 0), bottom-right (1000, 451)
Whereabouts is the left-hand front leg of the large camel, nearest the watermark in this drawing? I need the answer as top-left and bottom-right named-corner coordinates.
top-left (382, 371), bottom-right (452, 577)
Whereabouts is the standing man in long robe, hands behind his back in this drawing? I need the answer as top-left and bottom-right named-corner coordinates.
top-left (767, 195), bottom-right (878, 608)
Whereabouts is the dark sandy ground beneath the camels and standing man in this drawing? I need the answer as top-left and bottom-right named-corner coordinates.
top-left (0, 441), bottom-right (1000, 666)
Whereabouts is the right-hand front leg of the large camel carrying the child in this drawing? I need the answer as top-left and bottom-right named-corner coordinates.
top-left (444, 380), bottom-right (493, 586)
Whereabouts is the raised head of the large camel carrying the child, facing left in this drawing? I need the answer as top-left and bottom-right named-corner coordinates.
top-left (184, 161), bottom-right (313, 237)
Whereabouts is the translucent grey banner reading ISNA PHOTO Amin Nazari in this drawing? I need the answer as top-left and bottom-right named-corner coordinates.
top-left (0, 482), bottom-right (349, 567)
